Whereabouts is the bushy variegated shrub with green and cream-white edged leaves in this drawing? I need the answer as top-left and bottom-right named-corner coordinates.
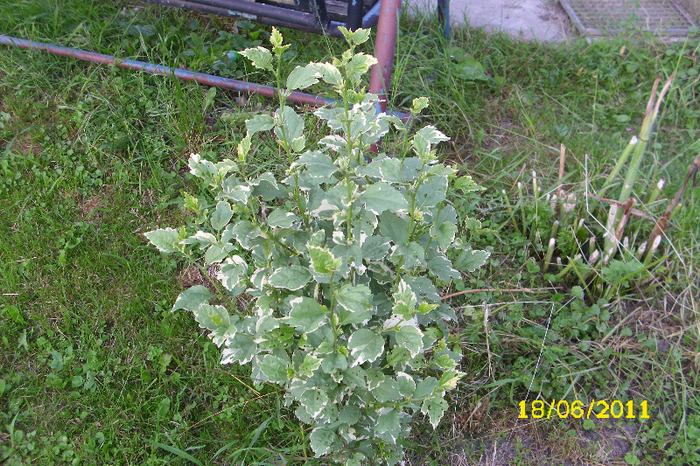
top-left (146, 30), bottom-right (488, 464)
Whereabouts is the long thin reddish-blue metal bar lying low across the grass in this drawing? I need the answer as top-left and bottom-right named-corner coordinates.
top-left (0, 35), bottom-right (338, 107)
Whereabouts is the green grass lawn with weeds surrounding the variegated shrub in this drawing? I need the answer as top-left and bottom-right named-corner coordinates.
top-left (0, 0), bottom-right (700, 464)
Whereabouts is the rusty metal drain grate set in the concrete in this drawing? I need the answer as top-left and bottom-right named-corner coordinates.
top-left (559, 0), bottom-right (695, 37)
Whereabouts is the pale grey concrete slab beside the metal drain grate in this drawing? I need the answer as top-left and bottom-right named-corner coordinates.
top-left (404, 0), bottom-right (571, 42)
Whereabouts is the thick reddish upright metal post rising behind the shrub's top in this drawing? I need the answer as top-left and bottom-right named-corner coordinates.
top-left (369, 0), bottom-right (401, 112)
